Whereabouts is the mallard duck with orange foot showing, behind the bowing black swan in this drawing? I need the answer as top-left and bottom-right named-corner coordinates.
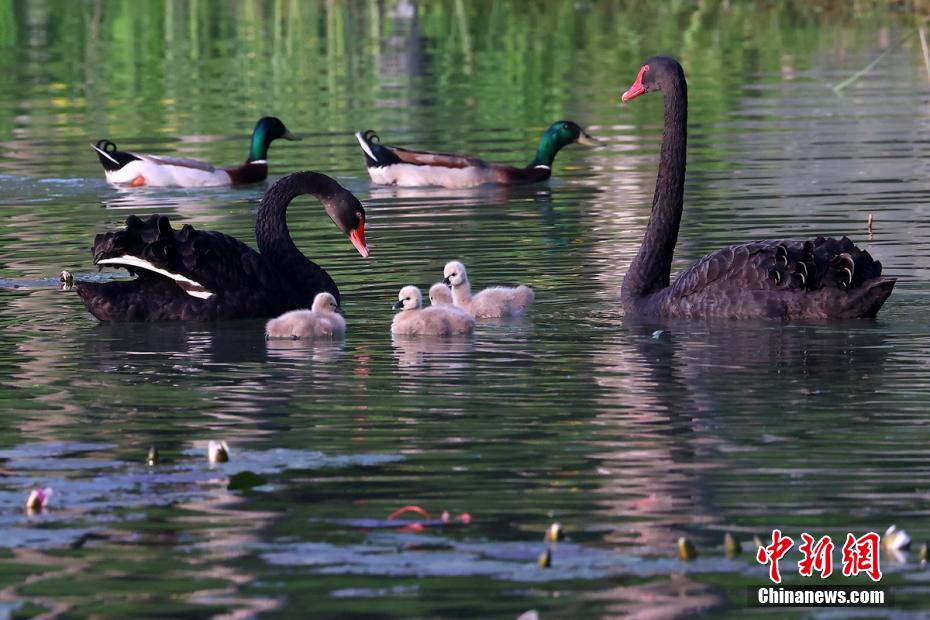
top-left (90, 116), bottom-right (300, 187)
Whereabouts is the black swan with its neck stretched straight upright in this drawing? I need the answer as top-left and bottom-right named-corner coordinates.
top-left (620, 56), bottom-right (895, 319)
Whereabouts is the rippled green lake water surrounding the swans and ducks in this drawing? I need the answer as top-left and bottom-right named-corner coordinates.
top-left (0, 0), bottom-right (930, 618)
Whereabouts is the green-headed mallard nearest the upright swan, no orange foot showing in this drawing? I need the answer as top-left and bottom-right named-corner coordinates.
top-left (355, 121), bottom-right (599, 188)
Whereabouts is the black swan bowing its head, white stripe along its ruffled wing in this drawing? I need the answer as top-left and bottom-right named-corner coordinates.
top-left (77, 172), bottom-right (369, 321)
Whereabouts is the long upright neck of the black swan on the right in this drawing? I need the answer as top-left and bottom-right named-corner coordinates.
top-left (621, 66), bottom-right (688, 300)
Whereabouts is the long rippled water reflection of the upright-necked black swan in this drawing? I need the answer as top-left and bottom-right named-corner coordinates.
top-left (595, 321), bottom-right (889, 555)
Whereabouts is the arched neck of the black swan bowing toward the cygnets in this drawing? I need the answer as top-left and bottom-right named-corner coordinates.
top-left (255, 172), bottom-right (345, 272)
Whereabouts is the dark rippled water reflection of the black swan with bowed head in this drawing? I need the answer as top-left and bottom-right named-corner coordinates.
top-left (74, 320), bottom-right (346, 424)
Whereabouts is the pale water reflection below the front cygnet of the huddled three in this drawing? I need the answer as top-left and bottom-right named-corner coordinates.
top-left (391, 334), bottom-right (475, 382)
